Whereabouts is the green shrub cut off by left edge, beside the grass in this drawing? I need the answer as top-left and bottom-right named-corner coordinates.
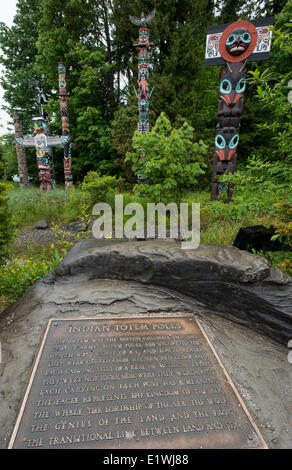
top-left (0, 183), bottom-right (15, 261)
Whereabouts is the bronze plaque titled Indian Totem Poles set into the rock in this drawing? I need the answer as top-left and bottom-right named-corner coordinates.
top-left (9, 315), bottom-right (267, 449)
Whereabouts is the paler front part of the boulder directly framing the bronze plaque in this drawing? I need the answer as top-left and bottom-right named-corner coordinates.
top-left (0, 274), bottom-right (292, 449)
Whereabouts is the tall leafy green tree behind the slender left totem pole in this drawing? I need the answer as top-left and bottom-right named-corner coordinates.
top-left (37, 0), bottom-right (116, 180)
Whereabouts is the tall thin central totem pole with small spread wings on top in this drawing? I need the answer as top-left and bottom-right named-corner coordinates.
top-left (129, 9), bottom-right (156, 184)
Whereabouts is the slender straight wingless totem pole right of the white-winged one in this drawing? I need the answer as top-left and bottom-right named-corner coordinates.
top-left (58, 62), bottom-right (73, 189)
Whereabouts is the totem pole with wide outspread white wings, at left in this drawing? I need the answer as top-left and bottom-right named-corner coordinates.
top-left (15, 78), bottom-right (64, 190)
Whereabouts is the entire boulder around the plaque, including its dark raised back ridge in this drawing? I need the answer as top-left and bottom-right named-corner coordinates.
top-left (0, 240), bottom-right (292, 448)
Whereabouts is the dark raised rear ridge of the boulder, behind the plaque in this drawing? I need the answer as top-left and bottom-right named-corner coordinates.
top-left (54, 239), bottom-right (292, 344)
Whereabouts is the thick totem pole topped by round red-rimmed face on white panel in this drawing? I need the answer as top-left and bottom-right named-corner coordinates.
top-left (205, 18), bottom-right (273, 201)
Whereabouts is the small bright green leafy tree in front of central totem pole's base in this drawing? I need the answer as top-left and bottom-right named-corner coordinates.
top-left (127, 113), bottom-right (207, 201)
